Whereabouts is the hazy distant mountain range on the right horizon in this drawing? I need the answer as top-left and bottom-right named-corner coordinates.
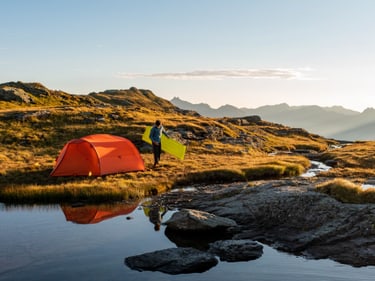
top-left (171, 97), bottom-right (375, 141)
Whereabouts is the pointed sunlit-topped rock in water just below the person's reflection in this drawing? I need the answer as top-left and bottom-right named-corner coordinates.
top-left (165, 209), bottom-right (237, 232)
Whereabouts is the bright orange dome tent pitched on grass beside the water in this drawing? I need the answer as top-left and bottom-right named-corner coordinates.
top-left (51, 134), bottom-right (145, 176)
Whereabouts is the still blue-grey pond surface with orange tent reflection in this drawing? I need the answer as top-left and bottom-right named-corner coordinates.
top-left (0, 199), bottom-right (375, 281)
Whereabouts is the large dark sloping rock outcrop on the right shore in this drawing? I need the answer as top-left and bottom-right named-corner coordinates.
top-left (156, 178), bottom-right (375, 266)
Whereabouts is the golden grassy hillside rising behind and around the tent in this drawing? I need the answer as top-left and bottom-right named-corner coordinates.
top-left (0, 82), bottom-right (371, 203)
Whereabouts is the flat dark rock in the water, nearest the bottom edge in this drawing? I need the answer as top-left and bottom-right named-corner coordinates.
top-left (125, 248), bottom-right (218, 274)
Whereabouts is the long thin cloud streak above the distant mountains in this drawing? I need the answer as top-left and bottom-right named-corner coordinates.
top-left (118, 68), bottom-right (311, 80)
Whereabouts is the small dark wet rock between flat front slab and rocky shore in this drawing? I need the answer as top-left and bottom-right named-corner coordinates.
top-left (209, 240), bottom-right (263, 262)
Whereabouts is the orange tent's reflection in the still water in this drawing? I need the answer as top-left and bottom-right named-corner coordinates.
top-left (61, 202), bottom-right (138, 224)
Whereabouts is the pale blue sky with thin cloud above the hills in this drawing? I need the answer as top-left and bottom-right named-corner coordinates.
top-left (0, 0), bottom-right (375, 112)
